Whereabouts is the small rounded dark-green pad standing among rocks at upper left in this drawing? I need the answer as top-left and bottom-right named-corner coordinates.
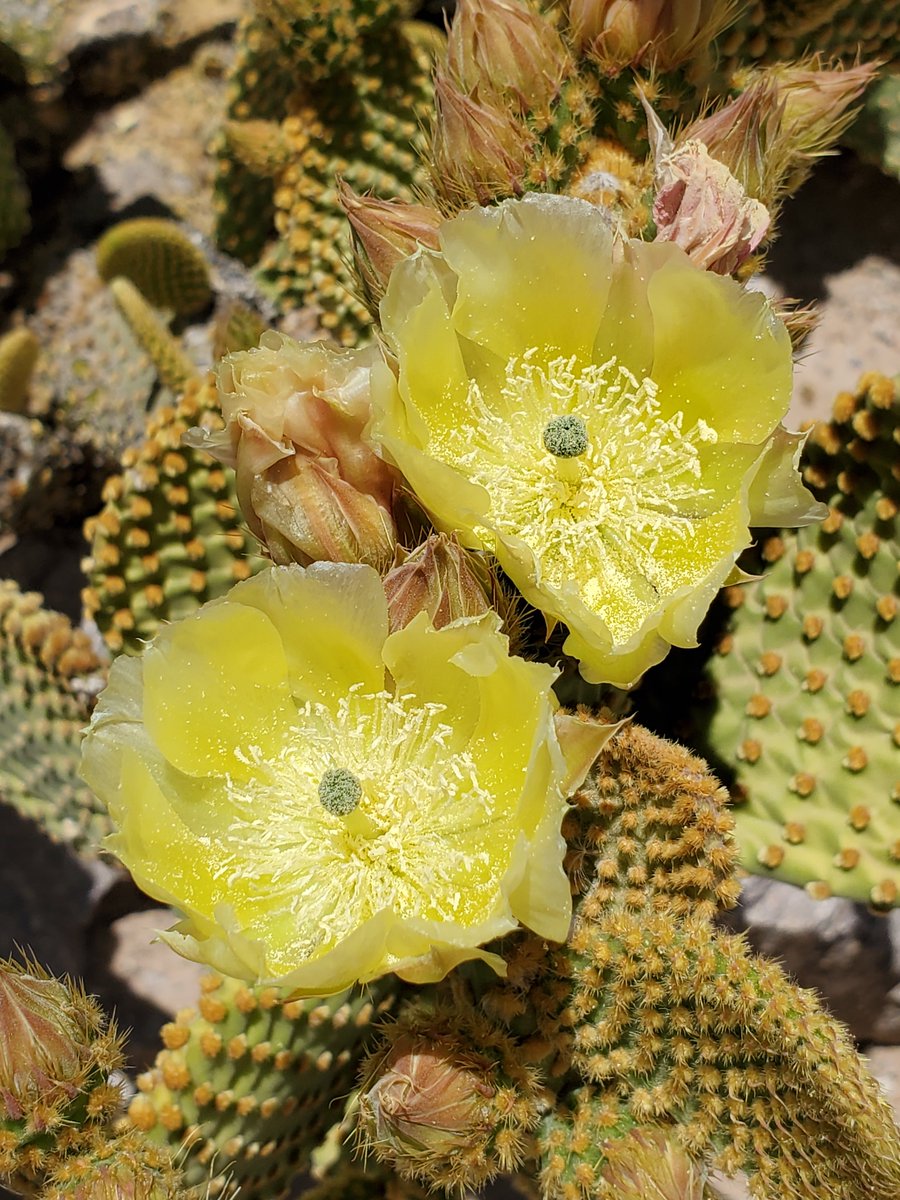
top-left (95, 217), bottom-right (212, 317)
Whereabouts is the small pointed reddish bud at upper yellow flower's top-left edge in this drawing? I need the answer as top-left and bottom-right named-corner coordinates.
top-left (337, 180), bottom-right (440, 305)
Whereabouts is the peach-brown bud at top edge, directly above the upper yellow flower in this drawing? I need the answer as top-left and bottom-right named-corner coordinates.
top-left (448, 0), bottom-right (568, 110)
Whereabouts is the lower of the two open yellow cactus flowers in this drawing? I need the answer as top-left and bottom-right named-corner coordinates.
top-left (83, 563), bottom-right (611, 995)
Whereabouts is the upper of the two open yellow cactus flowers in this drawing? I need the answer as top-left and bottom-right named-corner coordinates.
top-left (368, 196), bottom-right (823, 686)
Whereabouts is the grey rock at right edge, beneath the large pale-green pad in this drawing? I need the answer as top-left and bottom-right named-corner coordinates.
top-left (724, 876), bottom-right (900, 1042)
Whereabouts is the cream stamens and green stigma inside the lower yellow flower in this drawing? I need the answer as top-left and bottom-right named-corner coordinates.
top-left (221, 690), bottom-right (514, 970)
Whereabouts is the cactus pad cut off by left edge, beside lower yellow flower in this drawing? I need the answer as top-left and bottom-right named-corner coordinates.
top-left (0, 581), bottom-right (109, 854)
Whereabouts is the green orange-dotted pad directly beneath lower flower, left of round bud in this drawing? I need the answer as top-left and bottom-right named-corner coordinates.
top-left (128, 976), bottom-right (396, 1200)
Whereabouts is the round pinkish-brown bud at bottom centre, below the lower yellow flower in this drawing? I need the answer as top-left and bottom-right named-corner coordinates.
top-left (360, 1037), bottom-right (494, 1174)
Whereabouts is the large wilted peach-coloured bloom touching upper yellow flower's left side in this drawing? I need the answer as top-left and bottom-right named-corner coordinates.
top-left (186, 331), bottom-right (395, 568)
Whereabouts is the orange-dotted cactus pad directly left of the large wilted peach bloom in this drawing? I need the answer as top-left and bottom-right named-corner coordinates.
top-left (84, 380), bottom-right (264, 652)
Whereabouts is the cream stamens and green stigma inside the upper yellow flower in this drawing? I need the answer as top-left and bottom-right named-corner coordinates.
top-left (428, 350), bottom-right (716, 642)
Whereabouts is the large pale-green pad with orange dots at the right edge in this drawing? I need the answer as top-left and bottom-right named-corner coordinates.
top-left (697, 376), bottom-right (900, 908)
